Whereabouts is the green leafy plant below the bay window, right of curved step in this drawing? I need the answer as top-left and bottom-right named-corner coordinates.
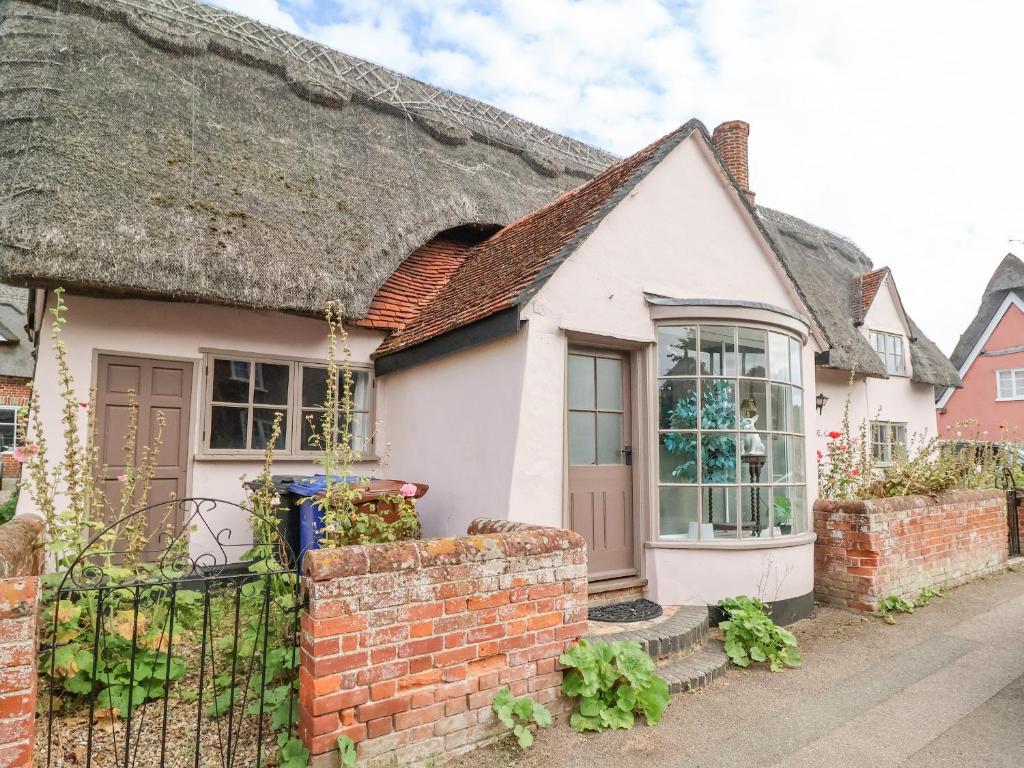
top-left (718, 595), bottom-right (800, 672)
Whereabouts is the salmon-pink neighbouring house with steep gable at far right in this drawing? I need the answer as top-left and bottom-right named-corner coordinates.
top-left (938, 253), bottom-right (1024, 440)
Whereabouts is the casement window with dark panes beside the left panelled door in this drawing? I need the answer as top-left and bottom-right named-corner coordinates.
top-left (203, 353), bottom-right (373, 456)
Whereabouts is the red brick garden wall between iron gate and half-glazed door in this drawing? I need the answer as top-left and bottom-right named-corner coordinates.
top-left (299, 520), bottom-right (587, 768)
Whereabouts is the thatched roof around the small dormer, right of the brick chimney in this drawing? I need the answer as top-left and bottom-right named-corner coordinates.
top-left (757, 206), bottom-right (961, 387)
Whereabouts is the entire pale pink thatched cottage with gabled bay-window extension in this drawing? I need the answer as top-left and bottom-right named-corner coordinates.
top-left (0, 0), bottom-right (958, 618)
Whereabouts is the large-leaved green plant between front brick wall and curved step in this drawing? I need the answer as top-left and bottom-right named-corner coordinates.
top-left (558, 640), bottom-right (669, 732)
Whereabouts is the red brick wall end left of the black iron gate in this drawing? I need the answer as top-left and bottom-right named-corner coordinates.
top-left (0, 517), bottom-right (43, 768)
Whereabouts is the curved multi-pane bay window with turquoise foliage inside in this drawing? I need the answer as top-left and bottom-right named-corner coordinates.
top-left (657, 323), bottom-right (807, 541)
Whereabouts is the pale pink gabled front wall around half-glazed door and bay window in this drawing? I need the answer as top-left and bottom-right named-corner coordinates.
top-left (509, 136), bottom-right (816, 604)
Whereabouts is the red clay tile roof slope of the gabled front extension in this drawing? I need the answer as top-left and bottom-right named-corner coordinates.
top-left (375, 120), bottom-right (707, 357)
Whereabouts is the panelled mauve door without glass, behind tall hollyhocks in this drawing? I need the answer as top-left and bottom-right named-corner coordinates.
top-left (96, 354), bottom-right (193, 556)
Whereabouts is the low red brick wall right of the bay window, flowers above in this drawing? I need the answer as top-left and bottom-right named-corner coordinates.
top-left (814, 490), bottom-right (1008, 610)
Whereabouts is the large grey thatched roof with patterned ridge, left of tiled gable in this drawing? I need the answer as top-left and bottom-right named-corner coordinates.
top-left (0, 0), bottom-right (614, 317)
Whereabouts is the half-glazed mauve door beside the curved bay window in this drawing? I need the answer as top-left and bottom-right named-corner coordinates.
top-left (566, 349), bottom-right (637, 581)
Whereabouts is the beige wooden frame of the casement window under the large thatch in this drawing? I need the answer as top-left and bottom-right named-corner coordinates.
top-left (200, 349), bottom-right (377, 460)
